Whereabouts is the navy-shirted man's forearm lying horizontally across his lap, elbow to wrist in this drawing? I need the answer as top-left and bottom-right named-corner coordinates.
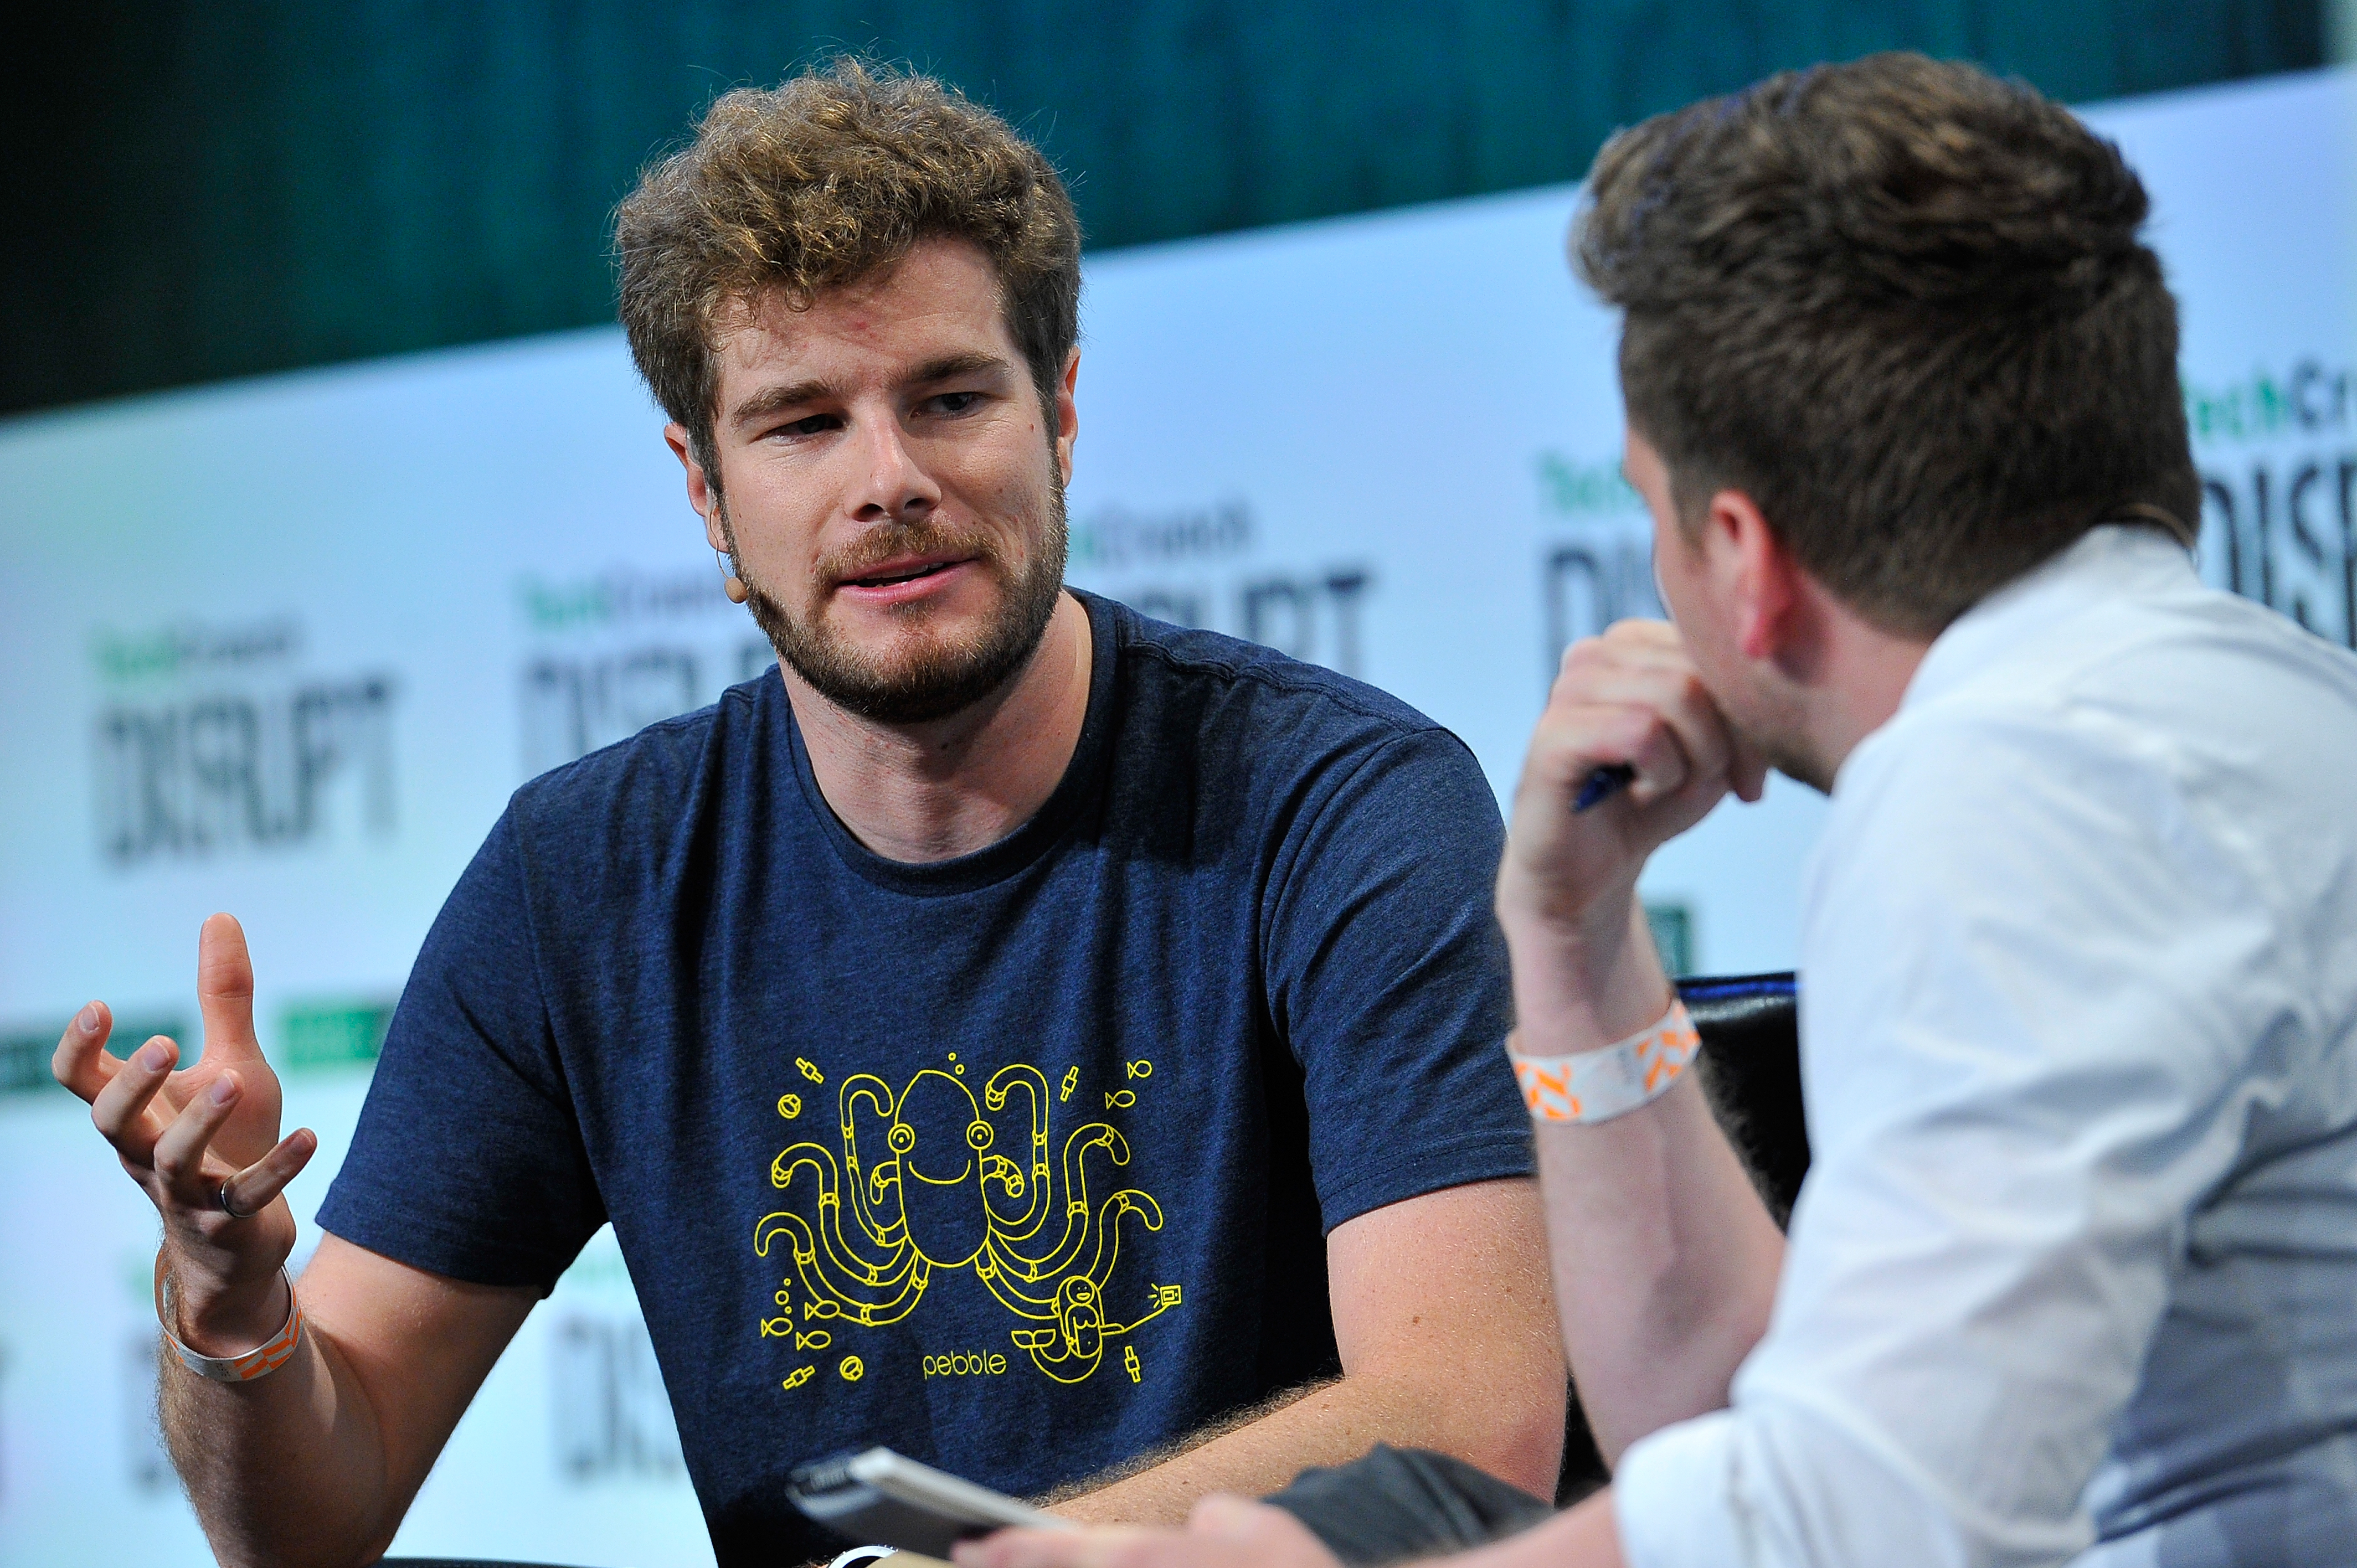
top-left (1056, 1368), bottom-right (1563, 1523)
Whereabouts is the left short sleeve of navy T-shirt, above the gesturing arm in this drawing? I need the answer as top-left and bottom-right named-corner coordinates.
top-left (318, 811), bottom-right (606, 1294)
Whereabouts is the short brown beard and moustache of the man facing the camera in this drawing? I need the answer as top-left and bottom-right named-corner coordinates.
top-left (721, 472), bottom-right (1068, 724)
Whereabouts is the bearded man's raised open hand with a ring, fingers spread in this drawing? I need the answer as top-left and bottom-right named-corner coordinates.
top-left (49, 915), bottom-right (318, 1353)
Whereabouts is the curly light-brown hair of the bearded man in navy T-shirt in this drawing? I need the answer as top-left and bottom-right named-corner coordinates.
top-left (615, 56), bottom-right (1079, 483)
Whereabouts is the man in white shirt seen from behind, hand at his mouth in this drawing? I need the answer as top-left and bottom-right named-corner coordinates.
top-left (959, 56), bottom-right (2357, 1568)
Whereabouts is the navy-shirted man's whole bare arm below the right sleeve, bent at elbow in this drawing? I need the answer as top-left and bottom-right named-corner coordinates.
top-left (1056, 1182), bottom-right (1565, 1523)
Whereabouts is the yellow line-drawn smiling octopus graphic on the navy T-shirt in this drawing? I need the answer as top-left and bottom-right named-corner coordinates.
top-left (752, 1064), bottom-right (1179, 1384)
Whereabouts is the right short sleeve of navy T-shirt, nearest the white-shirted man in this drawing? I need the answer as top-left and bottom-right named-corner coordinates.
top-left (1263, 729), bottom-right (1532, 1231)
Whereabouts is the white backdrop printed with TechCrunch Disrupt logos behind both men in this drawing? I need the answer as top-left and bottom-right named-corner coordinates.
top-left (0, 61), bottom-right (2357, 1566)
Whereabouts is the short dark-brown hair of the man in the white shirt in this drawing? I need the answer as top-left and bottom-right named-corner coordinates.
top-left (1572, 54), bottom-right (2201, 635)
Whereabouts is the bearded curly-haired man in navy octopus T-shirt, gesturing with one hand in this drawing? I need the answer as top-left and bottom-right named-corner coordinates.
top-left (56, 64), bottom-right (1565, 1563)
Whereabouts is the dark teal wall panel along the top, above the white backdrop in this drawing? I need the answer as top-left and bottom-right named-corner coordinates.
top-left (0, 0), bottom-right (2324, 410)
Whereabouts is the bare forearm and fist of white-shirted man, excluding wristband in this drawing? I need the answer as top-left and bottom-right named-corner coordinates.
top-left (1497, 622), bottom-right (1784, 1464)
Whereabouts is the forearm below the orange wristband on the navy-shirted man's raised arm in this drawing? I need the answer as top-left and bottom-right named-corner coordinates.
top-left (160, 1301), bottom-right (408, 1568)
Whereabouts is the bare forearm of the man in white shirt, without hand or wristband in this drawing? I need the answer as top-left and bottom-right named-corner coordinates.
top-left (1513, 901), bottom-right (1784, 1462)
